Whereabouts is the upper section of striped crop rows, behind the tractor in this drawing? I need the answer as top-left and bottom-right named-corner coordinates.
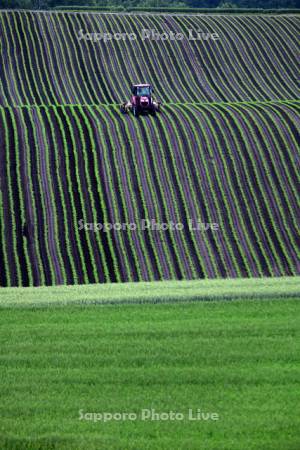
top-left (0, 11), bottom-right (300, 106)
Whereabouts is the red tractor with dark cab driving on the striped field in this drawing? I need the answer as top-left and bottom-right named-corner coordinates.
top-left (121, 84), bottom-right (160, 117)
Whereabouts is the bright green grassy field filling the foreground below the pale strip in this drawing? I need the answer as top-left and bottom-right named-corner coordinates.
top-left (0, 296), bottom-right (300, 450)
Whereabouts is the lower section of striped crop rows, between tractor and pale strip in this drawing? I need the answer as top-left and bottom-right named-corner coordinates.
top-left (0, 102), bottom-right (300, 285)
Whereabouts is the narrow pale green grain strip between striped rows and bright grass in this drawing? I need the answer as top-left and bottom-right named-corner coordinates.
top-left (0, 277), bottom-right (300, 307)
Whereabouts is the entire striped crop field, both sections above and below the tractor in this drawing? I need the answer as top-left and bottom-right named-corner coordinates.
top-left (0, 11), bottom-right (300, 286)
